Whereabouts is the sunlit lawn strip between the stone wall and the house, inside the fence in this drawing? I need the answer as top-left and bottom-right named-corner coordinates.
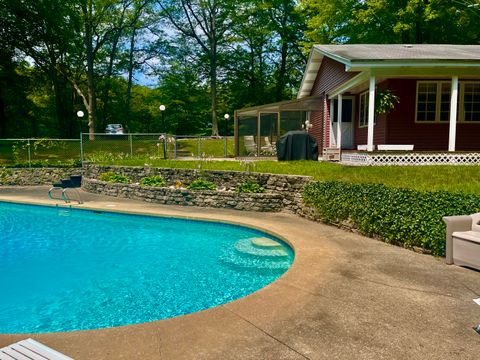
top-left (92, 158), bottom-right (480, 194)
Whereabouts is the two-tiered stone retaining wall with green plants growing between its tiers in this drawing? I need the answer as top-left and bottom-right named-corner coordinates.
top-left (83, 164), bottom-right (313, 213)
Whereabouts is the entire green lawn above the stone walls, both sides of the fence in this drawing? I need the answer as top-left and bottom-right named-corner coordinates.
top-left (0, 136), bottom-right (480, 194)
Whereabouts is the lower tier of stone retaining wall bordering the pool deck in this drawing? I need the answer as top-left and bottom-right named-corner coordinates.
top-left (82, 179), bottom-right (283, 212)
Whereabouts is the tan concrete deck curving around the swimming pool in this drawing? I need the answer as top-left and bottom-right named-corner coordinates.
top-left (0, 187), bottom-right (480, 360)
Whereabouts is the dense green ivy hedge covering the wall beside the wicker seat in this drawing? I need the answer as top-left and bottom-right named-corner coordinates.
top-left (303, 181), bottom-right (480, 256)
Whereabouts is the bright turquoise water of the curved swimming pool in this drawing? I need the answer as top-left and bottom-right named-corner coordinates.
top-left (0, 202), bottom-right (293, 333)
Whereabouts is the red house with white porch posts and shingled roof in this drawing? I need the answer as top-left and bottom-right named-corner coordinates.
top-left (237, 45), bottom-right (480, 163)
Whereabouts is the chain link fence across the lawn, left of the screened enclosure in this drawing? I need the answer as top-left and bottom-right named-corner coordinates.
top-left (0, 133), bottom-right (234, 166)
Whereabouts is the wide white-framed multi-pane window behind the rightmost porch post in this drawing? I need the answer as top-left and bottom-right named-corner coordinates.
top-left (416, 81), bottom-right (480, 123)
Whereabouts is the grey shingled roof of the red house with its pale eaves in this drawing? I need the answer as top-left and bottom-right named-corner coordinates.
top-left (298, 44), bottom-right (480, 98)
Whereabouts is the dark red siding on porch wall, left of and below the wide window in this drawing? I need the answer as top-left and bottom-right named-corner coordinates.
top-left (385, 79), bottom-right (480, 151)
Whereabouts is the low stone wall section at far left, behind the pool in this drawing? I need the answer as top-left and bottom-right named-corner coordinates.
top-left (0, 168), bottom-right (82, 186)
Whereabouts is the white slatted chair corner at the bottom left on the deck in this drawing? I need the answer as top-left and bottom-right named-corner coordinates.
top-left (0, 339), bottom-right (73, 360)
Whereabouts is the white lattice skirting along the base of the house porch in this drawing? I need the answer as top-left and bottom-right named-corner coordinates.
top-left (341, 152), bottom-right (480, 166)
